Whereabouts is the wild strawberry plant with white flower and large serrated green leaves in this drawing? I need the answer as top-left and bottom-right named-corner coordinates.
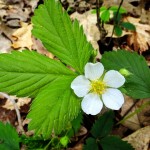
top-left (0, 0), bottom-right (150, 147)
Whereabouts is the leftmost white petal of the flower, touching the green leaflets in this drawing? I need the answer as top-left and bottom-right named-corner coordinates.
top-left (71, 75), bottom-right (91, 97)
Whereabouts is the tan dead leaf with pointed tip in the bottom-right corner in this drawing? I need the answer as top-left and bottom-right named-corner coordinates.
top-left (123, 126), bottom-right (150, 150)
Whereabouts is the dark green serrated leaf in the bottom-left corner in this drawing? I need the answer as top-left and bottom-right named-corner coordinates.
top-left (0, 122), bottom-right (19, 150)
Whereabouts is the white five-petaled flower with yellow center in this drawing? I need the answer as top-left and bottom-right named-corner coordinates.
top-left (71, 62), bottom-right (125, 115)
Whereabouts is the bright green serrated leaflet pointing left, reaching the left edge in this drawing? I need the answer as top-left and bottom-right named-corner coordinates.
top-left (0, 50), bottom-right (74, 97)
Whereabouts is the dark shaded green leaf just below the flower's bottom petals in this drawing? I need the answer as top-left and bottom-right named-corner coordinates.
top-left (91, 111), bottom-right (114, 138)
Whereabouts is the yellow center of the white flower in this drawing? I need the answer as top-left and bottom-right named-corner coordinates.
top-left (91, 80), bottom-right (106, 95)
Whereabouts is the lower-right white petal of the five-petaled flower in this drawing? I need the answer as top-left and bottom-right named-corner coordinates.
top-left (102, 88), bottom-right (124, 110)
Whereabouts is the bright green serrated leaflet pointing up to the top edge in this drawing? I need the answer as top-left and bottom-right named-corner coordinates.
top-left (32, 0), bottom-right (93, 74)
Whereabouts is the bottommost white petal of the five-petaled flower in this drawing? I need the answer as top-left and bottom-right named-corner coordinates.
top-left (81, 93), bottom-right (103, 115)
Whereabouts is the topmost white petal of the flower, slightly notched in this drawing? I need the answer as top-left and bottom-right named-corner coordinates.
top-left (85, 62), bottom-right (104, 80)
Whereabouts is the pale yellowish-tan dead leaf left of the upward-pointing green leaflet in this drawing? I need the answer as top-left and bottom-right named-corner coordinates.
top-left (12, 22), bottom-right (33, 50)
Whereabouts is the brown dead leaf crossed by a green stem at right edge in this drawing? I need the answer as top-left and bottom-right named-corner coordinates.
top-left (121, 96), bottom-right (150, 131)
